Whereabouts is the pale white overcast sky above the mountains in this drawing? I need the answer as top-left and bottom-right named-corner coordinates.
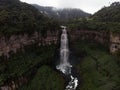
top-left (20, 0), bottom-right (120, 14)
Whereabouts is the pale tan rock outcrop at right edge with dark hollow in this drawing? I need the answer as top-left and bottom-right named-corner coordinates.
top-left (110, 32), bottom-right (120, 53)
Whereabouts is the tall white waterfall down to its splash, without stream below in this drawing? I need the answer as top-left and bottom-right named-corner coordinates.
top-left (57, 26), bottom-right (72, 74)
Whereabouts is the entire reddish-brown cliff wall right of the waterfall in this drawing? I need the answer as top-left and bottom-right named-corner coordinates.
top-left (69, 30), bottom-right (120, 54)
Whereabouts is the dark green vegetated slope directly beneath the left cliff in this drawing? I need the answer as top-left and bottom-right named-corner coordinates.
top-left (0, 45), bottom-right (55, 85)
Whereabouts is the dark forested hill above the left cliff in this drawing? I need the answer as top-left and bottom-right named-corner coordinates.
top-left (0, 0), bottom-right (59, 35)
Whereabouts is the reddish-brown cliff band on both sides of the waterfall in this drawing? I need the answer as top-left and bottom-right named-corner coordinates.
top-left (0, 30), bottom-right (120, 58)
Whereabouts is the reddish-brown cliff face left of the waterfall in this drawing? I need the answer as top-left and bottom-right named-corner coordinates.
top-left (0, 32), bottom-right (58, 57)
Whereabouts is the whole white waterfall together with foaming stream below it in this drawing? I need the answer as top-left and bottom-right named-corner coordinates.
top-left (56, 26), bottom-right (78, 90)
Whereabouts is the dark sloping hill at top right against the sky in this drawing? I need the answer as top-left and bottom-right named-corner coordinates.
top-left (93, 2), bottom-right (120, 22)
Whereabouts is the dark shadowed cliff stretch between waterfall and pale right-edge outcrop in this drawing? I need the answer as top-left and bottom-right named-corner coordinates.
top-left (71, 30), bottom-right (107, 44)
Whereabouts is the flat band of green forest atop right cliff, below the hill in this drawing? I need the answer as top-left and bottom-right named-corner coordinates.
top-left (67, 18), bottom-right (120, 33)
